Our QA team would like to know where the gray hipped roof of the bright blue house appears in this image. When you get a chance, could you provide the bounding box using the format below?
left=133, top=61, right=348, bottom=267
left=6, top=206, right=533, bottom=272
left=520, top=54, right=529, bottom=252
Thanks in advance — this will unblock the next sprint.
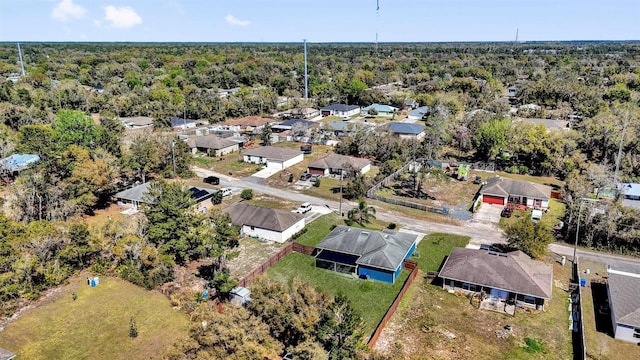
left=316, top=226, right=417, bottom=271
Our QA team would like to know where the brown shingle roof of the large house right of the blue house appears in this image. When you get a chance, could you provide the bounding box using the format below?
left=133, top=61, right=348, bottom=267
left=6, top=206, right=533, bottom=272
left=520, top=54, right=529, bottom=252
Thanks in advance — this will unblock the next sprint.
left=439, top=248, right=553, bottom=299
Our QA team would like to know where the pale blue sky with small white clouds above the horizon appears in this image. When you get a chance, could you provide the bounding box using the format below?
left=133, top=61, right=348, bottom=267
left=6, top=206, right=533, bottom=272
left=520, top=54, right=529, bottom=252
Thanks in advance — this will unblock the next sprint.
left=0, top=0, right=640, bottom=42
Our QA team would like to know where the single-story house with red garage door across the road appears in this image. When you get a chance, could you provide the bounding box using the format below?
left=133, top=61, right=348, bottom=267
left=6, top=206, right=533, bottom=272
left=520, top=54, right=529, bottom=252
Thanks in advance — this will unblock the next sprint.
left=480, top=176, right=551, bottom=210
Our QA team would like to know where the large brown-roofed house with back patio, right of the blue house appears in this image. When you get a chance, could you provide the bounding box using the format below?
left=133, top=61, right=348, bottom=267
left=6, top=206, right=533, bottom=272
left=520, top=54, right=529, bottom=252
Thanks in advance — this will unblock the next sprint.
left=438, top=248, right=553, bottom=309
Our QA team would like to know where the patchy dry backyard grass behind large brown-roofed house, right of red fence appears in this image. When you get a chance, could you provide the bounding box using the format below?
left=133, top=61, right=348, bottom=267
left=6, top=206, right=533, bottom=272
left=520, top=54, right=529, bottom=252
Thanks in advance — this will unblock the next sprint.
left=376, top=258, right=573, bottom=360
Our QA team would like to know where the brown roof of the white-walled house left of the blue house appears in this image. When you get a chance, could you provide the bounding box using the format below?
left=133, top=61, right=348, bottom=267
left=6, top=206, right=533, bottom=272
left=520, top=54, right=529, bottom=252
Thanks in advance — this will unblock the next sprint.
left=224, top=203, right=304, bottom=231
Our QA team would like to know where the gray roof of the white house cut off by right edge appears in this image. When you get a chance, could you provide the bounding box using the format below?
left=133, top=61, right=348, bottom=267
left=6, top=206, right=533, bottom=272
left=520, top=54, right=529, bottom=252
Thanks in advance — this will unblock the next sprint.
left=607, top=265, right=640, bottom=327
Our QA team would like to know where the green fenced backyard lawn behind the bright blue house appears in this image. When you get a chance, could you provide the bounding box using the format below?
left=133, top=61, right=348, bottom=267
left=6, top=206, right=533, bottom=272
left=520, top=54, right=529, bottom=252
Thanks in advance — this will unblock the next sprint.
left=266, top=253, right=409, bottom=341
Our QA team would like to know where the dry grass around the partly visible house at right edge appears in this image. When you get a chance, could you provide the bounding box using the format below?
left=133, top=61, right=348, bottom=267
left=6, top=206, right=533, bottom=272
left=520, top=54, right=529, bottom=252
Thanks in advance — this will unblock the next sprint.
left=580, top=260, right=640, bottom=360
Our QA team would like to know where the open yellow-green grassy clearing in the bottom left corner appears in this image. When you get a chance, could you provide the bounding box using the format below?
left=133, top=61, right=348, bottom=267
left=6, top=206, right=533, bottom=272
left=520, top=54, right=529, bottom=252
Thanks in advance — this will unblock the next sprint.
left=0, top=275, right=189, bottom=359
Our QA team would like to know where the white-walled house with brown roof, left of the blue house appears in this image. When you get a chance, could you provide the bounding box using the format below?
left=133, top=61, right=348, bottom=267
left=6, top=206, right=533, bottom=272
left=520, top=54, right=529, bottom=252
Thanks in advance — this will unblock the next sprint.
left=224, top=203, right=305, bottom=243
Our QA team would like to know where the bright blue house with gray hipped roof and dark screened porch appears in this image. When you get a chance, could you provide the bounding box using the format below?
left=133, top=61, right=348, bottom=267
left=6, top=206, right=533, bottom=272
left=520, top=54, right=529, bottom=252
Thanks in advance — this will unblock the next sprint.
left=316, top=225, right=418, bottom=283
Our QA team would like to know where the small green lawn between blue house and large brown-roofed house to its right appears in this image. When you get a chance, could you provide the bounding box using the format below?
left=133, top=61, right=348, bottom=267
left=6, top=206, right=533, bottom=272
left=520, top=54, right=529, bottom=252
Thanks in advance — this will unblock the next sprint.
left=411, top=233, right=469, bottom=271
